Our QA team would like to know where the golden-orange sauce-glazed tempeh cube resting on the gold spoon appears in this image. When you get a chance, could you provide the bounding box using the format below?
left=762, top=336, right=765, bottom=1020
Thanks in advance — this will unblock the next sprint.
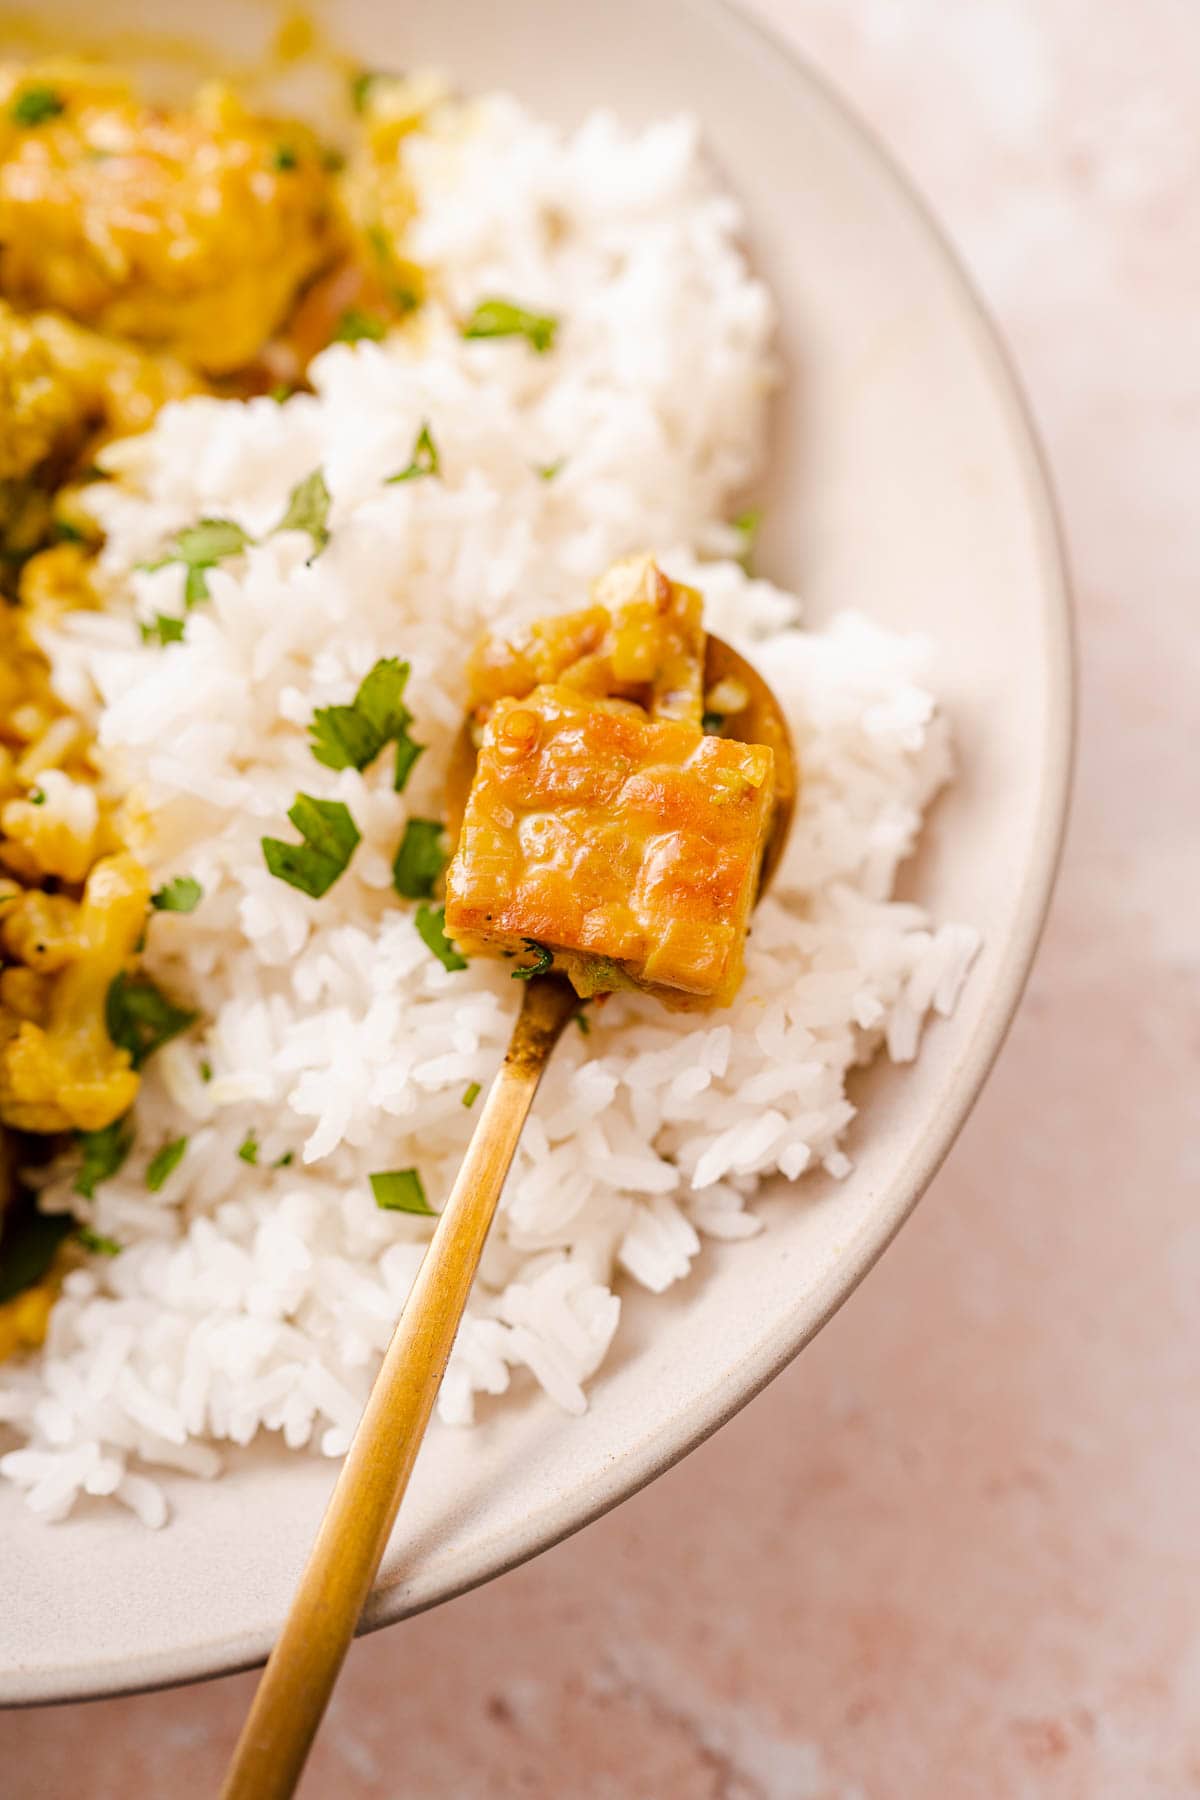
left=446, top=686, right=774, bottom=1006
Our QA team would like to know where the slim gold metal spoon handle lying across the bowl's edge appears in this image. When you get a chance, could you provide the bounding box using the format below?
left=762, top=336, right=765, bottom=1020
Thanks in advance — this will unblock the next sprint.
left=221, top=976, right=579, bottom=1800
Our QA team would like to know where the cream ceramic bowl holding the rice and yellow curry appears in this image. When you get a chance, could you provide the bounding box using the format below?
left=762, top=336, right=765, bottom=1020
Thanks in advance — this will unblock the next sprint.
left=0, top=0, right=1072, bottom=1703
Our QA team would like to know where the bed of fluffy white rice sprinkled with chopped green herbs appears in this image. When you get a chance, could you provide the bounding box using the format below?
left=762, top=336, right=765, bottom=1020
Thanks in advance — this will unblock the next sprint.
left=0, top=87, right=975, bottom=1525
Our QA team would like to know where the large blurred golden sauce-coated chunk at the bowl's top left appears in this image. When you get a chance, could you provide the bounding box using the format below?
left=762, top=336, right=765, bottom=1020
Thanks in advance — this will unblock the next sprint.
left=0, top=63, right=335, bottom=373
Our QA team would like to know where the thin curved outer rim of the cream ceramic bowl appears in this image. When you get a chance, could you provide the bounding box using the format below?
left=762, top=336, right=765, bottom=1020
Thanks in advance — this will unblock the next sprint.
left=0, top=0, right=1078, bottom=1710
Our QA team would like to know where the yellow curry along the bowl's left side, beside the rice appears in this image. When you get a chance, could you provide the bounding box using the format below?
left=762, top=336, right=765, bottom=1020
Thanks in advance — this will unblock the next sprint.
left=0, top=61, right=443, bottom=1357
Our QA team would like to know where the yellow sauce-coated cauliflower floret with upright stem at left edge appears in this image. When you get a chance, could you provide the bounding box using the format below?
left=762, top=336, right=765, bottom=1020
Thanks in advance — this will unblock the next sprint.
left=0, top=855, right=149, bottom=1132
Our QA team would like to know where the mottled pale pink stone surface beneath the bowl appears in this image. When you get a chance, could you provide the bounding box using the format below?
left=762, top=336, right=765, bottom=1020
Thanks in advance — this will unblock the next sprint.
left=0, top=0, right=1200, bottom=1800
